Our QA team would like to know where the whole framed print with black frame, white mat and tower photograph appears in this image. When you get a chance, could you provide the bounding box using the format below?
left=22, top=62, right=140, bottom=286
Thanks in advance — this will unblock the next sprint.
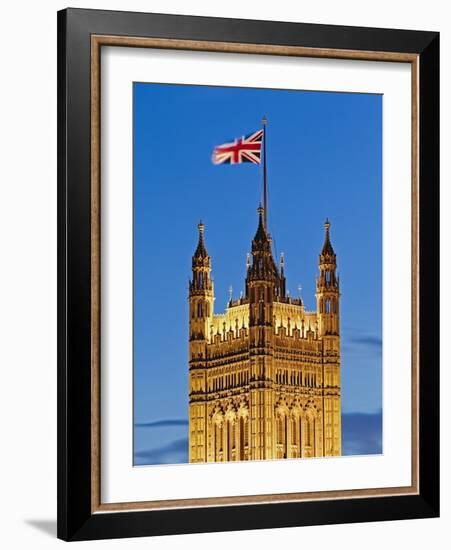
left=58, top=9, right=439, bottom=540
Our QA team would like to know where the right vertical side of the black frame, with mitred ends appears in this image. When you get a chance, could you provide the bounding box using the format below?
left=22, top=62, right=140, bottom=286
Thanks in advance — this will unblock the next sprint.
left=419, top=33, right=440, bottom=515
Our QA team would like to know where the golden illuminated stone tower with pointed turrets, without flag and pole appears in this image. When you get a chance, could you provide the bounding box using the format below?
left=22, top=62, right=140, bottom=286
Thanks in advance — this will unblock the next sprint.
left=189, top=207, right=341, bottom=463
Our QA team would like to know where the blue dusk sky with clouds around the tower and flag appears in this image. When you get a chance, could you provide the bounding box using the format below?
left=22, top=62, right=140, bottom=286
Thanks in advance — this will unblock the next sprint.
left=133, top=83, right=382, bottom=464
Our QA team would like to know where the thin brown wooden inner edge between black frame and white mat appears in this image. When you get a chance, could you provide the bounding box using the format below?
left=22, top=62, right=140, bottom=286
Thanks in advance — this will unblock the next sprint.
left=90, top=34, right=420, bottom=514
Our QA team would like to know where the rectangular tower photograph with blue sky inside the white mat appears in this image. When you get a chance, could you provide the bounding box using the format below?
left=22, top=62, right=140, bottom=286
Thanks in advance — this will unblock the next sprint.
left=130, top=82, right=384, bottom=467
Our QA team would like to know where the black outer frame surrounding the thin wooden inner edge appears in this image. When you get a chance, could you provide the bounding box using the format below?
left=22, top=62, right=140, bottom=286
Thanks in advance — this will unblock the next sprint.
left=57, top=9, right=439, bottom=540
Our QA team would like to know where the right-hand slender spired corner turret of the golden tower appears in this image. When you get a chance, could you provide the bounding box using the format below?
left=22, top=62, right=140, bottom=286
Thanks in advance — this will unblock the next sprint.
left=316, top=219, right=340, bottom=336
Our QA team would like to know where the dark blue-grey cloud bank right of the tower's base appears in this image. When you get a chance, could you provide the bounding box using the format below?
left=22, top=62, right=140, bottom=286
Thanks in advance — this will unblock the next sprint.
left=341, top=411, right=382, bottom=455
